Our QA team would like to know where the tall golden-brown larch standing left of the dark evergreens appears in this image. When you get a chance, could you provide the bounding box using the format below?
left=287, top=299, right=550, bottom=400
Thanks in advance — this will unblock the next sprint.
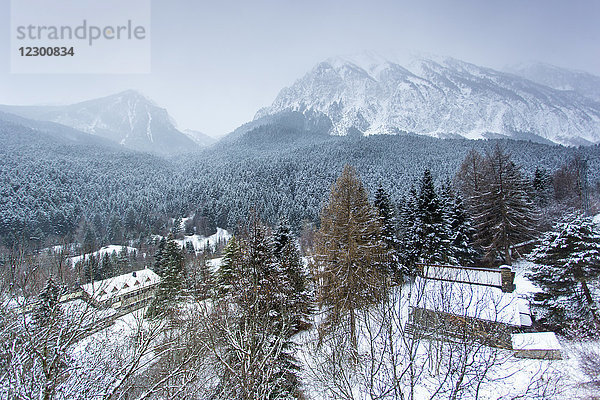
left=315, top=165, right=386, bottom=356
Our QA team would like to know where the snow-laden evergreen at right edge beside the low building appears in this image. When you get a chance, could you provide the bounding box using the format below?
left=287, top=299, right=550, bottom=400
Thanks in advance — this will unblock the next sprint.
left=529, top=214, right=600, bottom=336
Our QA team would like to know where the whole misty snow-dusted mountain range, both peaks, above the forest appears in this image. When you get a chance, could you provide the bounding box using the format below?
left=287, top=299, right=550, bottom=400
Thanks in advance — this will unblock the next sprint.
left=0, top=53, right=600, bottom=154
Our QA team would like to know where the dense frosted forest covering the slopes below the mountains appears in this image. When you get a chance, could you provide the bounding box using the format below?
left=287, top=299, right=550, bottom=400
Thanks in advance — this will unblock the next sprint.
left=0, top=117, right=600, bottom=245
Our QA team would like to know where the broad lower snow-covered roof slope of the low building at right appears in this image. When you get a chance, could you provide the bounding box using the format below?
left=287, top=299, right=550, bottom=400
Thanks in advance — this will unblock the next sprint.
left=412, top=277, right=531, bottom=326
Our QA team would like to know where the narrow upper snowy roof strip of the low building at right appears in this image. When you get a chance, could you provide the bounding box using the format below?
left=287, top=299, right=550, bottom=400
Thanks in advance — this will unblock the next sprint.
left=423, top=265, right=502, bottom=287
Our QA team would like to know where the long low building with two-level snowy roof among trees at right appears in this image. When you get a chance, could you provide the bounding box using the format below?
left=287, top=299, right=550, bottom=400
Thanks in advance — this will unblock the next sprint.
left=408, top=266, right=532, bottom=349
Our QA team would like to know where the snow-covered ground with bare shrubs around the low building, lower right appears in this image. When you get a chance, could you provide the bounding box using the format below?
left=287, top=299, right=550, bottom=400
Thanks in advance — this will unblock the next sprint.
left=295, top=261, right=600, bottom=400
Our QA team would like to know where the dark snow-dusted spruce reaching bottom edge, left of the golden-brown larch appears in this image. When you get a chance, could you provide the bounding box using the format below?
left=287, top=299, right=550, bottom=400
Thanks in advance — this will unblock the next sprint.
left=217, top=215, right=299, bottom=399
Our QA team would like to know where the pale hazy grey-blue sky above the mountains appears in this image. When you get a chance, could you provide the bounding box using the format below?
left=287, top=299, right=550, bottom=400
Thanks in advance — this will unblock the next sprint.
left=0, top=0, right=600, bottom=136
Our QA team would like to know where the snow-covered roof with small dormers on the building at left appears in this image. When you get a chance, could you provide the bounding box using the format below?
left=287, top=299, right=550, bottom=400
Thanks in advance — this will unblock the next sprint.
left=82, top=268, right=160, bottom=302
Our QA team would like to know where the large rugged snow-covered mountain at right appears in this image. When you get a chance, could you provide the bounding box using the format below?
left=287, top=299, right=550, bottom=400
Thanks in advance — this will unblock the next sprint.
left=255, top=54, right=600, bottom=145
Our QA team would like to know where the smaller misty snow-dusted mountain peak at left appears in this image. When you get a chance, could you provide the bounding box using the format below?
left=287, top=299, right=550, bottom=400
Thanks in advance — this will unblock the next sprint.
left=0, top=90, right=197, bottom=154
